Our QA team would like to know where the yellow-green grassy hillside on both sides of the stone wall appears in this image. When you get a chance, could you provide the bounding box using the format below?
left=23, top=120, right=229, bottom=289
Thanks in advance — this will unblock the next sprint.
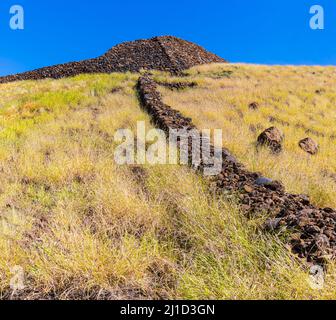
left=0, top=65, right=336, bottom=299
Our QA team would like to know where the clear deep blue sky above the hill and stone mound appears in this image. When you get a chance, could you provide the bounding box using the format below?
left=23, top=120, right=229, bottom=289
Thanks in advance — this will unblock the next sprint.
left=0, top=0, right=336, bottom=75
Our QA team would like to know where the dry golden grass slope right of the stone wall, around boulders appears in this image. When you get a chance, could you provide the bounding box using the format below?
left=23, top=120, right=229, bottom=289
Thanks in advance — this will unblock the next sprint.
left=157, top=64, right=336, bottom=207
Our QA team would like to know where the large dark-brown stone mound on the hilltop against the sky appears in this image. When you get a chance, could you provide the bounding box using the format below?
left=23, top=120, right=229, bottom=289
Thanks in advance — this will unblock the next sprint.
left=0, top=36, right=226, bottom=83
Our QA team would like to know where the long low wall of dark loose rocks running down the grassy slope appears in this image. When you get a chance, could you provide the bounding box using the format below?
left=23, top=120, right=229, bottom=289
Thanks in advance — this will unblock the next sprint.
left=138, top=77, right=336, bottom=264
